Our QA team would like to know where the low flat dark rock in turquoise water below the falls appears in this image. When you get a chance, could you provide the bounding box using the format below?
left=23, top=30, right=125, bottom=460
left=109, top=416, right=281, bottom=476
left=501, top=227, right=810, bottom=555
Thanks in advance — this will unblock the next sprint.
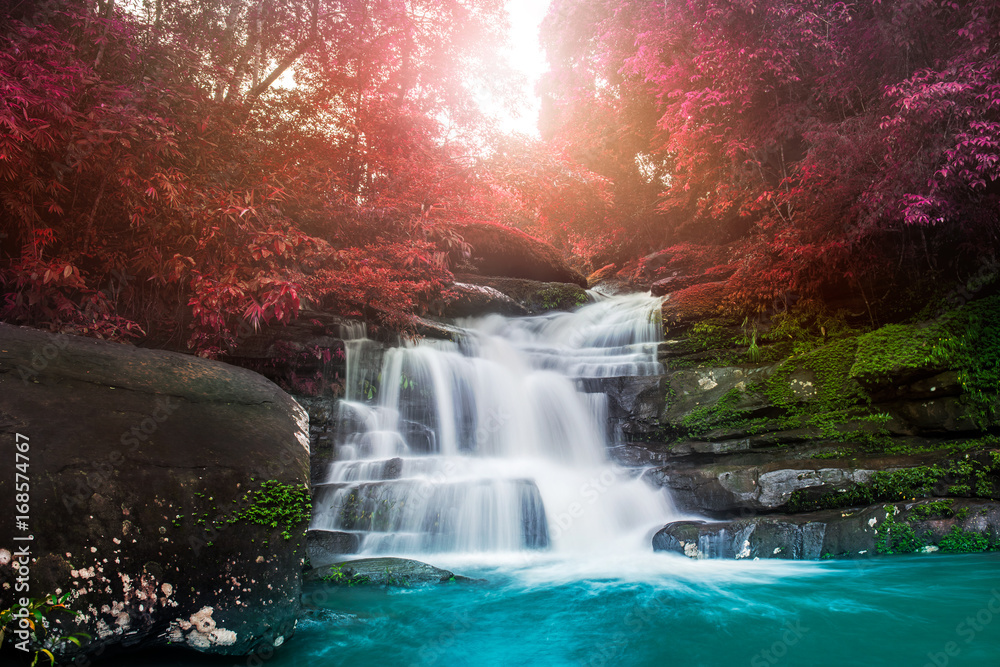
left=305, top=557, right=476, bottom=587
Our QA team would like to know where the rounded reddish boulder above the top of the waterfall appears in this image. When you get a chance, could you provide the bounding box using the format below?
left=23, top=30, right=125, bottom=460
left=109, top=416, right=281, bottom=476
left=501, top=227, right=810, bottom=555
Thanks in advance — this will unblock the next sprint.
left=454, top=222, right=587, bottom=287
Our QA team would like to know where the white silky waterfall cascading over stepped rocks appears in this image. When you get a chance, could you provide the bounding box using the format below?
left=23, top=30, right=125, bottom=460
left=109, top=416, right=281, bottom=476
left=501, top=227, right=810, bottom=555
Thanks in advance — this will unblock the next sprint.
left=312, top=295, right=671, bottom=554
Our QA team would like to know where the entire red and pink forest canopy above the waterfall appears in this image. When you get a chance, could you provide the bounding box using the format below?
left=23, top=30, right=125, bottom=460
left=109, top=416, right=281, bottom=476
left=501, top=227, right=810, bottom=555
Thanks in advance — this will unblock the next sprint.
left=0, top=0, right=1000, bottom=356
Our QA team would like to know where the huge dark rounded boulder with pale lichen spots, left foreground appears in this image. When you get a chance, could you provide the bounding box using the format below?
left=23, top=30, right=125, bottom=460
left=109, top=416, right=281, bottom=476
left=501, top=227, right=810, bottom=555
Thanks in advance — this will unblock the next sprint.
left=0, top=324, right=309, bottom=655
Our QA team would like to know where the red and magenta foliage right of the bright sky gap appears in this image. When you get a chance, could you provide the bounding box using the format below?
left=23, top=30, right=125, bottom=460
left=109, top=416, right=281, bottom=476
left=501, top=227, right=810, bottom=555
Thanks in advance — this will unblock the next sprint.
left=546, top=0, right=1000, bottom=310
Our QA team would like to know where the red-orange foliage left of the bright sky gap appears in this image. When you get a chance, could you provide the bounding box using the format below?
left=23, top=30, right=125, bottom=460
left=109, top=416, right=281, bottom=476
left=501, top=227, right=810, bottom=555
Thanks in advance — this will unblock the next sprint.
left=0, top=0, right=503, bottom=356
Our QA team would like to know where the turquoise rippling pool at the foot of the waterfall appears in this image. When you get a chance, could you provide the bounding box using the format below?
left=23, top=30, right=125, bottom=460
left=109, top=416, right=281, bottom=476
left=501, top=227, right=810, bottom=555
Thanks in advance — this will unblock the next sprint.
left=278, top=554, right=1000, bottom=667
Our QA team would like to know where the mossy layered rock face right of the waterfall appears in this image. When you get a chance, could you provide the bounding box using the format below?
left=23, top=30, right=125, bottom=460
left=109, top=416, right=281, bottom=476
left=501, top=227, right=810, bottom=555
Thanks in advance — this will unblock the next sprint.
left=584, top=290, right=1000, bottom=558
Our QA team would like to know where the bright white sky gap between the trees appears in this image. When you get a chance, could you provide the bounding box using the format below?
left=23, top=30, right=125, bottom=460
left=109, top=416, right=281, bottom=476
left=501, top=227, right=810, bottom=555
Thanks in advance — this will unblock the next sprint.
left=500, top=0, right=551, bottom=137
